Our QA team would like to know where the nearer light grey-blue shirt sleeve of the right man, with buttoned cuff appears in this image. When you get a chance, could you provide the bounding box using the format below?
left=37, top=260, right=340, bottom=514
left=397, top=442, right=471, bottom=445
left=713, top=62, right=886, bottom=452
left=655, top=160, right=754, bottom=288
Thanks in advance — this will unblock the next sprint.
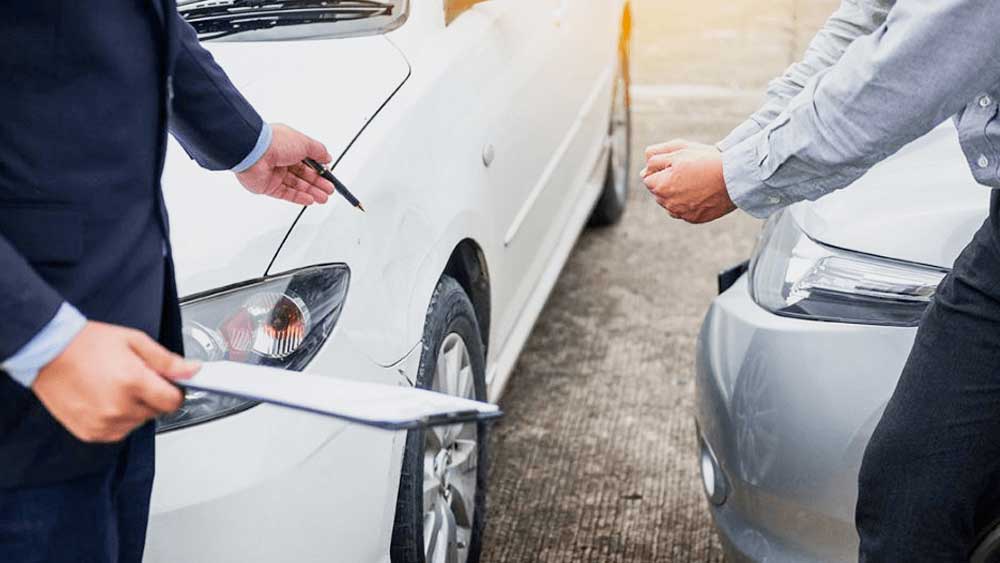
left=723, top=0, right=1000, bottom=217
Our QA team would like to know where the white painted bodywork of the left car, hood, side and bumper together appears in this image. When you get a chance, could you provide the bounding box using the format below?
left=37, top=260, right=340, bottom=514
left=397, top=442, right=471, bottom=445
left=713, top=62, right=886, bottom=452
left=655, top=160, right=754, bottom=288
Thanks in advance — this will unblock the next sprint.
left=146, top=0, right=624, bottom=563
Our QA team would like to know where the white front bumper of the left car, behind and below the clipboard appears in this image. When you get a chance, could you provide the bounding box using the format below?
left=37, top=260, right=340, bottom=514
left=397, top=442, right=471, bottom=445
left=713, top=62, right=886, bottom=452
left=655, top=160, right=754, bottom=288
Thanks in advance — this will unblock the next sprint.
left=145, top=334, right=419, bottom=563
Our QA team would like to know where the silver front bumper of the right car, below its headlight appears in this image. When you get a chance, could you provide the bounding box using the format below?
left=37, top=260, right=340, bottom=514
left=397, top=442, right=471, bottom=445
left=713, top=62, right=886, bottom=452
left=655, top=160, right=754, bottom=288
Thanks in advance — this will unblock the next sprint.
left=695, top=276, right=916, bottom=562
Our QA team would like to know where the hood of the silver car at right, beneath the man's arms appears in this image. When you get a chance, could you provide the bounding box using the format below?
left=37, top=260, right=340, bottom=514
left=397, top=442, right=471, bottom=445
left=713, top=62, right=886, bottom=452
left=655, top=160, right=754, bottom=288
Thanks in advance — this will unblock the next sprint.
left=792, top=124, right=991, bottom=268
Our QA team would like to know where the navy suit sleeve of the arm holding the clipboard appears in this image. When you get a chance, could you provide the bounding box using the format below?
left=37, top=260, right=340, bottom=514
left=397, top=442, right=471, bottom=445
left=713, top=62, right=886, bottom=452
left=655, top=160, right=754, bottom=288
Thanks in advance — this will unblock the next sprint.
left=0, top=235, right=64, bottom=362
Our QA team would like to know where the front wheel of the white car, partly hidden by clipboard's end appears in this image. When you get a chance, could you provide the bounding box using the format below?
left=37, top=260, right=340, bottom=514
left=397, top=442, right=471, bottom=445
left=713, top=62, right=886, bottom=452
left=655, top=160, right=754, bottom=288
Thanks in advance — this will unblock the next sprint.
left=390, top=276, right=488, bottom=563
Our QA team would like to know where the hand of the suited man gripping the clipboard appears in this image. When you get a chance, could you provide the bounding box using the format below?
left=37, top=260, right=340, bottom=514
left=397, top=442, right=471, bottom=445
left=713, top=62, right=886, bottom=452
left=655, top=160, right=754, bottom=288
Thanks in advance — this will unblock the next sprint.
left=31, top=322, right=199, bottom=442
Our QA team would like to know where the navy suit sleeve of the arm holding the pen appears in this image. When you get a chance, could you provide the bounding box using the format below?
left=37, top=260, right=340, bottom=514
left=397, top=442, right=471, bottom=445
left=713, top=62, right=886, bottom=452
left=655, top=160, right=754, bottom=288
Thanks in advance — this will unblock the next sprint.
left=170, top=14, right=265, bottom=170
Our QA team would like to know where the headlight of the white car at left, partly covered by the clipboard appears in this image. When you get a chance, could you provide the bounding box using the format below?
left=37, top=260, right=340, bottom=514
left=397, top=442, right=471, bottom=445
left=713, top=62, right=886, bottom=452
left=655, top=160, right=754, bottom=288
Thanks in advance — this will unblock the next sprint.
left=158, top=265, right=350, bottom=432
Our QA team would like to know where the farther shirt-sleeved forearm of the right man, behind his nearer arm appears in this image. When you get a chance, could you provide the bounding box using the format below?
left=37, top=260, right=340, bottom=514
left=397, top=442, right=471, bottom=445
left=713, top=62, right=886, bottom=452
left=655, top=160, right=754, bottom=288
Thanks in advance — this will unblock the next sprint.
left=718, top=0, right=891, bottom=150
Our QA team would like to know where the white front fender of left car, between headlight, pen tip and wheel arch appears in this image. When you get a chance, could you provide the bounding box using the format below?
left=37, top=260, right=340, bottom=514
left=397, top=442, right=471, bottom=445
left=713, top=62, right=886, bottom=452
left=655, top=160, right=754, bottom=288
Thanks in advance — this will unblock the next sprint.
left=268, top=93, right=492, bottom=366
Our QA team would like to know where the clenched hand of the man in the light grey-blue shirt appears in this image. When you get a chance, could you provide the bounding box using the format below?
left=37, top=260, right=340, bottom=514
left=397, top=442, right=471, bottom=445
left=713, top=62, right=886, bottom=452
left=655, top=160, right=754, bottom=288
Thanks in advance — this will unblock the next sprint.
left=642, top=139, right=736, bottom=223
